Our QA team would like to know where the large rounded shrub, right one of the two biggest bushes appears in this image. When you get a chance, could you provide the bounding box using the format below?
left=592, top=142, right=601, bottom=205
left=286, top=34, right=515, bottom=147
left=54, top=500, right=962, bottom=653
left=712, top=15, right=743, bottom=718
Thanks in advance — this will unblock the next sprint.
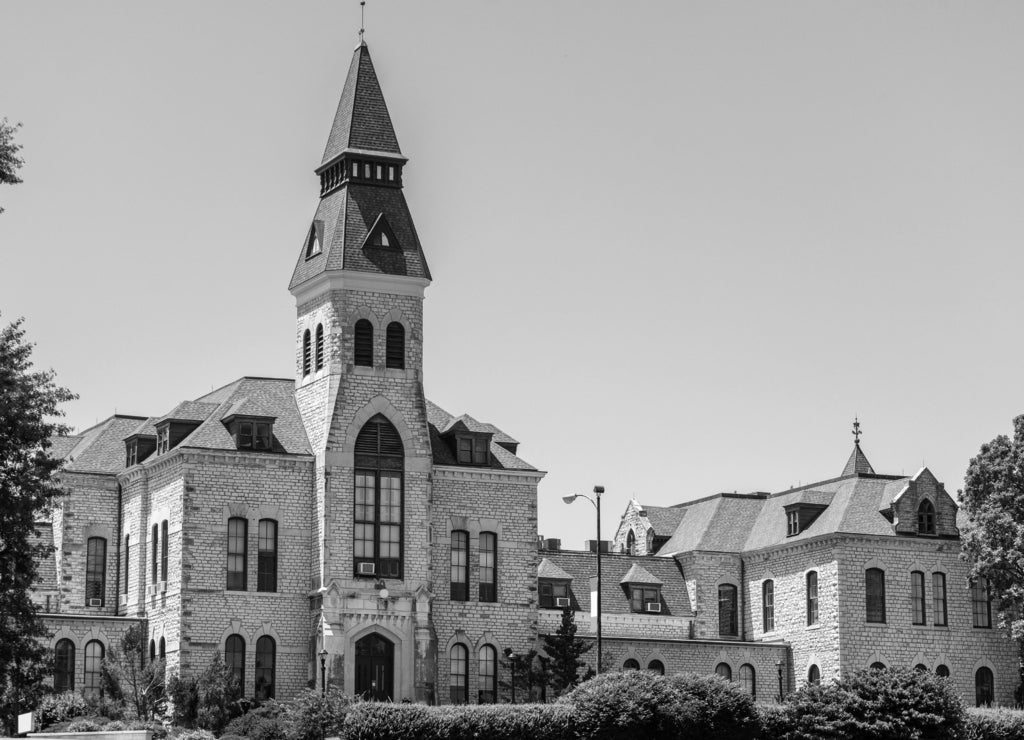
left=780, top=668, right=966, bottom=740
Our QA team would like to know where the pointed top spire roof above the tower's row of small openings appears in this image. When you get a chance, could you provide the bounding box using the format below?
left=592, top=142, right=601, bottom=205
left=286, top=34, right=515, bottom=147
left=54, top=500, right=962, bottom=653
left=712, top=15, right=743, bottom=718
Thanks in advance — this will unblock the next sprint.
left=321, top=42, right=401, bottom=165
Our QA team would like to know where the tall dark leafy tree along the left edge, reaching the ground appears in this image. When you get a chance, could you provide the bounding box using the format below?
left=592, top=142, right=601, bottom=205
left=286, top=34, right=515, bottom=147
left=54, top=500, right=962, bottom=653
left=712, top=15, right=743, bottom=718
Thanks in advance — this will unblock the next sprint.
left=0, top=317, right=75, bottom=730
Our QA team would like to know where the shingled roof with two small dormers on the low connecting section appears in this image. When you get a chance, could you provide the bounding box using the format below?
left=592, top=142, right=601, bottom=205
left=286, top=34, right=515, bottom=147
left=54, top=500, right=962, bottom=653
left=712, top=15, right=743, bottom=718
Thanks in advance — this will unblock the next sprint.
left=542, top=551, right=693, bottom=616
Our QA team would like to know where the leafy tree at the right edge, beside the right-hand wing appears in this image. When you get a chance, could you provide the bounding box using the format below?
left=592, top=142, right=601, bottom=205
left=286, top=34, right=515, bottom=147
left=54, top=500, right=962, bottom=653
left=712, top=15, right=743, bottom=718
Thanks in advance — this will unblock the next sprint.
left=959, top=416, right=1024, bottom=691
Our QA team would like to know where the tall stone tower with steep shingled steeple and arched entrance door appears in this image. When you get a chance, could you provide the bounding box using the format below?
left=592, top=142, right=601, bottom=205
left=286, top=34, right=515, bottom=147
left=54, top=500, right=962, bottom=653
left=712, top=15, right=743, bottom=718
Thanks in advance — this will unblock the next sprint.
left=289, top=42, right=436, bottom=701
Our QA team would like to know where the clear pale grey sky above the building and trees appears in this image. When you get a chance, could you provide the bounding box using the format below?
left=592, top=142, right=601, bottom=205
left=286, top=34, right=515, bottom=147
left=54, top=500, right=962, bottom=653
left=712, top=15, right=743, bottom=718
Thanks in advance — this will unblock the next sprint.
left=0, top=0, right=1024, bottom=547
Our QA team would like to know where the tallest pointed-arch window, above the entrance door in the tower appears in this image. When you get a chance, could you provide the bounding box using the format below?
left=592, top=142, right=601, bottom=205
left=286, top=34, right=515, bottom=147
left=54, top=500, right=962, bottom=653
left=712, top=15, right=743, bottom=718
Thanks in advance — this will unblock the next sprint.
left=353, top=417, right=404, bottom=578
